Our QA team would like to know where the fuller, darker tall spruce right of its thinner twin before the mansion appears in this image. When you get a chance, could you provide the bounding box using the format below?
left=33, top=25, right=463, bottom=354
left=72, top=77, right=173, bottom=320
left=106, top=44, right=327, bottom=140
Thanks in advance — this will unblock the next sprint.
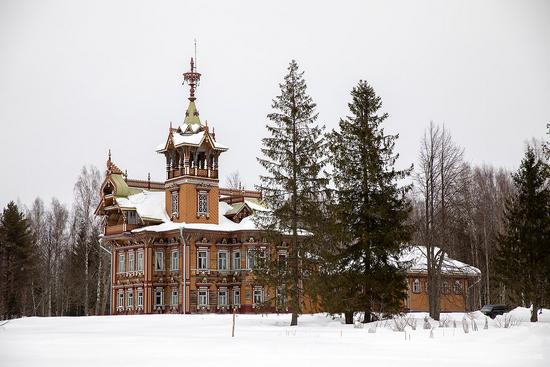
left=321, top=81, right=412, bottom=322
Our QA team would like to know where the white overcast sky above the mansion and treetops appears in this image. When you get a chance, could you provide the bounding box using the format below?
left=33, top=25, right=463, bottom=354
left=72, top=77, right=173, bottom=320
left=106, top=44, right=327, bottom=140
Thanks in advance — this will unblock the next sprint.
left=0, top=0, right=550, bottom=211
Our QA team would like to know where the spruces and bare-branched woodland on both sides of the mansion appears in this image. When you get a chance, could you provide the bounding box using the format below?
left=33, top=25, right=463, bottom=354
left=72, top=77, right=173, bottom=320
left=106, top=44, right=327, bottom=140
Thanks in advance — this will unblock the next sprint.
left=0, top=61, right=550, bottom=325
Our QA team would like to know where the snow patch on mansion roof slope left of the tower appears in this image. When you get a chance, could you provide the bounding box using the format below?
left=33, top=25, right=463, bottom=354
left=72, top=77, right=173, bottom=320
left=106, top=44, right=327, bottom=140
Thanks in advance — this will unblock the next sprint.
left=116, top=190, right=170, bottom=222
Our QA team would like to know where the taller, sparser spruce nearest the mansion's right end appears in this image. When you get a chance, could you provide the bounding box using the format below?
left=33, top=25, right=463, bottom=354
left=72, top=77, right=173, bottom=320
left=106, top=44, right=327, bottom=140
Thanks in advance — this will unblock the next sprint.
left=257, top=60, right=327, bottom=326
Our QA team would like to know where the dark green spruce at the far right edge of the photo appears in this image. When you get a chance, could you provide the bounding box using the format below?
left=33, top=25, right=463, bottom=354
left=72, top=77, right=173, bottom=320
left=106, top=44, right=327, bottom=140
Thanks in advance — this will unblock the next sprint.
left=496, top=147, right=550, bottom=322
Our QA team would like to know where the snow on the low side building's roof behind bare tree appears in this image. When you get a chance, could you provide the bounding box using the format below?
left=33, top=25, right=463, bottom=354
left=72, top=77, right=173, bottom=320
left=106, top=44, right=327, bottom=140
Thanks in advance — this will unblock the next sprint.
left=399, top=246, right=481, bottom=275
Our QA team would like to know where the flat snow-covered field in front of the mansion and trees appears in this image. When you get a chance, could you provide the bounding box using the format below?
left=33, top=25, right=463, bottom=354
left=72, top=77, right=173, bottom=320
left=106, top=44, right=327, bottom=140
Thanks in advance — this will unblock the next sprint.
left=0, top=309, right=550, bottom=367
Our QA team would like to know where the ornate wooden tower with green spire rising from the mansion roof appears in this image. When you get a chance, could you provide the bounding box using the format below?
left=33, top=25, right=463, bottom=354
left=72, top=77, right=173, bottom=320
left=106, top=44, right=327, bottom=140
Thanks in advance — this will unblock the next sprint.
left=157, top=58, right=227, bottom=224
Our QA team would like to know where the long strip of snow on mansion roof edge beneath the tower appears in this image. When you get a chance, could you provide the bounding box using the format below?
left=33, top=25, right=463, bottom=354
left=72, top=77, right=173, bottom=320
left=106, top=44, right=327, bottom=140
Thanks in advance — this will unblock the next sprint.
left=132, top=201, right=259, bottom=233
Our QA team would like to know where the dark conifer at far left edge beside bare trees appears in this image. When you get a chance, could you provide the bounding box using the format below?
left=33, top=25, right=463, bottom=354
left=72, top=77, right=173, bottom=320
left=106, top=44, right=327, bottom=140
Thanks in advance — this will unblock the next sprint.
left=0, top=201, right=35, bottom=317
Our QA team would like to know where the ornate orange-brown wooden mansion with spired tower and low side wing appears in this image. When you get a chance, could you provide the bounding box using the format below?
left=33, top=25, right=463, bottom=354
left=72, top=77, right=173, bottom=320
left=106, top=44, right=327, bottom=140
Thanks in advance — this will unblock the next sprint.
left=96, top=59, right=480, bottom=314
